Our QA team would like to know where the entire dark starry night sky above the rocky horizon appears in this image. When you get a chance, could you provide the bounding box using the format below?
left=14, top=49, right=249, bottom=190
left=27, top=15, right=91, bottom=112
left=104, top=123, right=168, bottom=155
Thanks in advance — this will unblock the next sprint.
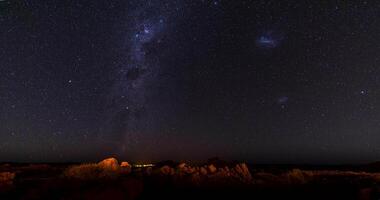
left=0, top=0, right=380, bottom=164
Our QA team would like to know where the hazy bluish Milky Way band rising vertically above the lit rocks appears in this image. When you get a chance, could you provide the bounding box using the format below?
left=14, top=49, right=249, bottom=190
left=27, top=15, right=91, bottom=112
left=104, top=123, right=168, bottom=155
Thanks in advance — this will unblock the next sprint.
left=112, top=1, right=181, bottom=156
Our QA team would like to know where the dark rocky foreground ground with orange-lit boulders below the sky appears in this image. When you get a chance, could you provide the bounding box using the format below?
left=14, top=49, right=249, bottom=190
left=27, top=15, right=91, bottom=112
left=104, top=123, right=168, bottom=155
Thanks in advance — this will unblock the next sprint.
left=0, top=158, right=380, bottom=200
